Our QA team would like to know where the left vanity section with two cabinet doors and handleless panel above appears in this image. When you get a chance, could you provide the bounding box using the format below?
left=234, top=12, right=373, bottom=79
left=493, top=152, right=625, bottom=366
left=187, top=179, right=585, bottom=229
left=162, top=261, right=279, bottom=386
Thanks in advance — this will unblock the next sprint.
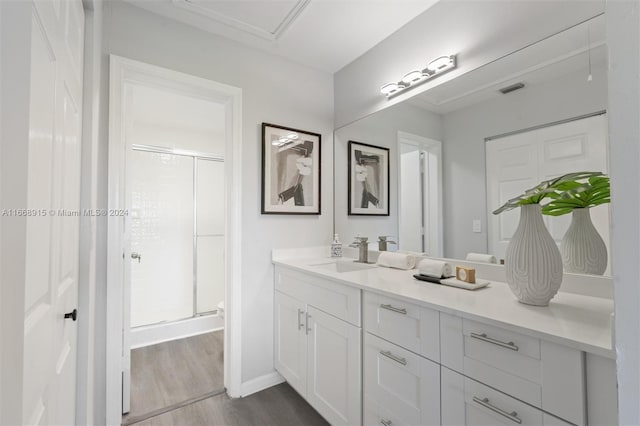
left=274, top=267, right=362, bottom=425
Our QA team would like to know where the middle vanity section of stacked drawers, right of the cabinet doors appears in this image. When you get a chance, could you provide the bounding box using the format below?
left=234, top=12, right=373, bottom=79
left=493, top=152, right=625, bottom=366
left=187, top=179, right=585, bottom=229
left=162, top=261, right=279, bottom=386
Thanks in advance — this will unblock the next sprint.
left=363, top=292, right=440, bottom=426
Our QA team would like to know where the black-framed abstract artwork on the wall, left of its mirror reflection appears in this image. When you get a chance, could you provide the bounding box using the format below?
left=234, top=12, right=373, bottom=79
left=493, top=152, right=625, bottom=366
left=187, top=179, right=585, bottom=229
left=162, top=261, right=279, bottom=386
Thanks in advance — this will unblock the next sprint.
left=261, top=123, right=322, bottom=214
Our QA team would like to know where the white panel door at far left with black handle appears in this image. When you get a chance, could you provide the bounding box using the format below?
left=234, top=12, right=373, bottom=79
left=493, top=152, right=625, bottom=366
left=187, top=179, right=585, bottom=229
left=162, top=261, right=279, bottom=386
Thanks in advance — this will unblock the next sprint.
left=22, top=0, right=86, bottom=425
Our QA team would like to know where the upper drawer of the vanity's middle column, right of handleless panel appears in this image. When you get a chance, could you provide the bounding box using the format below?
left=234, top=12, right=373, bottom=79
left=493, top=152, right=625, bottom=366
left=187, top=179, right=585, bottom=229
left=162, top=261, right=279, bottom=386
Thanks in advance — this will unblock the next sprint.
left=364, top=292, right=440, bottom=362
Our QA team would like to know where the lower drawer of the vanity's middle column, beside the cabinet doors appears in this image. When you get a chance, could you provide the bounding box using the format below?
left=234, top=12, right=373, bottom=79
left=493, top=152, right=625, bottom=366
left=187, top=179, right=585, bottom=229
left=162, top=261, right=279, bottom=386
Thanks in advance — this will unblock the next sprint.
left=363, top=333, right=440, bottom=425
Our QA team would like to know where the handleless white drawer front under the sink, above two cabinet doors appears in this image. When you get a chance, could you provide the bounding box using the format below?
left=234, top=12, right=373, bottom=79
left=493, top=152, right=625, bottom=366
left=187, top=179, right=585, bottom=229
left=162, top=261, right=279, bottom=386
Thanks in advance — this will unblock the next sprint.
left=275, top=267, right=361, bottom=327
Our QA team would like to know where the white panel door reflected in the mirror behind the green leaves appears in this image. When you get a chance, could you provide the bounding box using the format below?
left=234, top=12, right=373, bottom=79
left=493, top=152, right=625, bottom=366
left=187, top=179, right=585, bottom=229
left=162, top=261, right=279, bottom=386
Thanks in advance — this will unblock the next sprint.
left=486, top=114, right=610, bottom=264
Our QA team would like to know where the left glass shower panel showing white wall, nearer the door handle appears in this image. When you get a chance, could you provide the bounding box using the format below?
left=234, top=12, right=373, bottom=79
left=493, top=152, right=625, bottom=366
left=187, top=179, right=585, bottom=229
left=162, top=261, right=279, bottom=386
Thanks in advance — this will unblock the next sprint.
left=130, top=150, right=194, bottom=327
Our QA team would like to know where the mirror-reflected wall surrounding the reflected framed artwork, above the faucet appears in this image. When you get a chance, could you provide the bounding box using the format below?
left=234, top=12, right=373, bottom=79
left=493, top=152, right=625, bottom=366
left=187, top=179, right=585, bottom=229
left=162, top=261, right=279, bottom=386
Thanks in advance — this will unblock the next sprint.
left=334, top=103, right=442, bottom=248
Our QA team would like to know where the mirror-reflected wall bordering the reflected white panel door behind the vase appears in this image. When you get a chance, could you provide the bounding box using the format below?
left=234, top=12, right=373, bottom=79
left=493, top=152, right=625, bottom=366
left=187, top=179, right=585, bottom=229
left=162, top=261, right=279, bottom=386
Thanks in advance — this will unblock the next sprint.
left=443, top=65, right=607, bottom=259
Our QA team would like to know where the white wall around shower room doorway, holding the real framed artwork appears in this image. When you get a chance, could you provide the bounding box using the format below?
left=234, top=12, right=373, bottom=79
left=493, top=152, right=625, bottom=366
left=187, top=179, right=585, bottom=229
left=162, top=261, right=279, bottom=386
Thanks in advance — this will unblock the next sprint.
left=98, top=2, right=333, bottom=402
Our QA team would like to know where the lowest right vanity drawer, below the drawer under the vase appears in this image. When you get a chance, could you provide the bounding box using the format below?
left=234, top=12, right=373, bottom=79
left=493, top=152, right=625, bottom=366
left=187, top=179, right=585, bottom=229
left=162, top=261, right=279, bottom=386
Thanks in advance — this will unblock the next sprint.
left=442, top=368, right=570, bottom=426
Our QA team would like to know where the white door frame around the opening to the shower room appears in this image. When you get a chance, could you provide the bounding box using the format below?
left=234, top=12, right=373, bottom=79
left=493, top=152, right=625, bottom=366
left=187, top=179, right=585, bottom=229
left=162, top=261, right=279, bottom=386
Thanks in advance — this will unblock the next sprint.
left=106, top=55, right=242, bottom=425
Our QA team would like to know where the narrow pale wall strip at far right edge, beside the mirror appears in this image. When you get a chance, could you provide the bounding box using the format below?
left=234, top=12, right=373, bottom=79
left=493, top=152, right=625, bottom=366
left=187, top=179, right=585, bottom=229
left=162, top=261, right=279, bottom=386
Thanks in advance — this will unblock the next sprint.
left=606, top=0, right=640, bottom=425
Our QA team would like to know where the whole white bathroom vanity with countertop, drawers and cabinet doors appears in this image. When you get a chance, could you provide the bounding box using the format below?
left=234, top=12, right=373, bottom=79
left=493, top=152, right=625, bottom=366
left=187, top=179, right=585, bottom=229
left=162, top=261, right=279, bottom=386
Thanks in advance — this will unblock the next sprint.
left=273, top=249, right=617, bottom=426
